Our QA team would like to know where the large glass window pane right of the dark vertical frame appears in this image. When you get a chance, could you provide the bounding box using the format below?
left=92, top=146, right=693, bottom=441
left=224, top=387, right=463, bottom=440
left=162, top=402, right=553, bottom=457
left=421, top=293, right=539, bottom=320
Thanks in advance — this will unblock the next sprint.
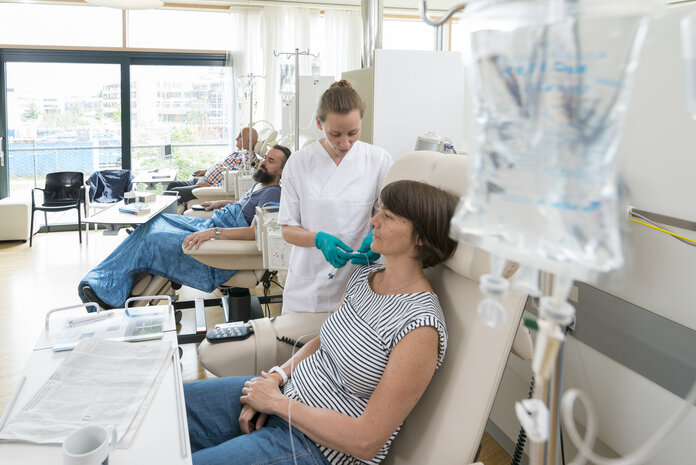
left=131, top=65, right=236, bottom=179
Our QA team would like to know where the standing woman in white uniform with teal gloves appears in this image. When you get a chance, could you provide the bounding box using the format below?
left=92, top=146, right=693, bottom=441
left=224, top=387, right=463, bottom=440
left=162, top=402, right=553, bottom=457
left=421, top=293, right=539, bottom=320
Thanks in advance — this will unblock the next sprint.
left=278, top=80, right=393, bottom=314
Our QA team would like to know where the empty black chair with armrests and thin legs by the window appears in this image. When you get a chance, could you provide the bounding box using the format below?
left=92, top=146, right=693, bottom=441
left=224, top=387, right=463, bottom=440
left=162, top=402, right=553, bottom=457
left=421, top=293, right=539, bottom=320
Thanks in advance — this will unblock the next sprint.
left=29, top=171, right=87, bottom=247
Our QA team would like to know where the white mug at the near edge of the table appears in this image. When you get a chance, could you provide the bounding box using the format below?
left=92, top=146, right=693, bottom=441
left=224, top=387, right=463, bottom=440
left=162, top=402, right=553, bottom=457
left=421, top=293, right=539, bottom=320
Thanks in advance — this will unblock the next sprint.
left=63, top=425, right=118, bottom=465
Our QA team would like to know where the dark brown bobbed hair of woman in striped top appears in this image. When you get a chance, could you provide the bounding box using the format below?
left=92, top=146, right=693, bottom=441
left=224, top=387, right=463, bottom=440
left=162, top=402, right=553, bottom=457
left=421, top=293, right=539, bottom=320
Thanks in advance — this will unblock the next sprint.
left=380, top=180, right=459, bottom=268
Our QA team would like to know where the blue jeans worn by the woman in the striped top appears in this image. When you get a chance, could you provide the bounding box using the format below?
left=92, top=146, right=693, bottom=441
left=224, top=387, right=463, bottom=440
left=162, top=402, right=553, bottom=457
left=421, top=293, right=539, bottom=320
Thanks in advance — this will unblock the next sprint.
left=184, top=376, right=328, bottom=465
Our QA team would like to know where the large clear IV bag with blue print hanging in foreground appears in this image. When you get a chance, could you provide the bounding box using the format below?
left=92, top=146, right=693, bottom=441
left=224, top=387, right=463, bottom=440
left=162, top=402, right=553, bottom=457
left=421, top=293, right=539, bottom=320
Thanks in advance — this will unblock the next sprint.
left=451, top=0, right=654, bottom=280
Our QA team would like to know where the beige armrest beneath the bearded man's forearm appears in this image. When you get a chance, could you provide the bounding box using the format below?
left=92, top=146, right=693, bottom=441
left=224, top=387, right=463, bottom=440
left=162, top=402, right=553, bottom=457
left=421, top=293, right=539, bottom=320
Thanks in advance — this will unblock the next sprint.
left=182, top=240, right=264, bottom=270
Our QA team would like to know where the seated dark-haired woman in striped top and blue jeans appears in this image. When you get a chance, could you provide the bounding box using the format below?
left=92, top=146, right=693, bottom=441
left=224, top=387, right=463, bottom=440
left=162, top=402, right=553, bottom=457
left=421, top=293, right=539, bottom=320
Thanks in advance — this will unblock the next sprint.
left=184, top=181, right=457, bottom=465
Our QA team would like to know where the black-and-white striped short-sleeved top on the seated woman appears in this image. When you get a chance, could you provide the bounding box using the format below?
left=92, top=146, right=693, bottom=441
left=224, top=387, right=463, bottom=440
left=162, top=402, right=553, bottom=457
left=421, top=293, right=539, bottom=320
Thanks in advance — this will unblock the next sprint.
left=284, top=264, right=447, bottom=465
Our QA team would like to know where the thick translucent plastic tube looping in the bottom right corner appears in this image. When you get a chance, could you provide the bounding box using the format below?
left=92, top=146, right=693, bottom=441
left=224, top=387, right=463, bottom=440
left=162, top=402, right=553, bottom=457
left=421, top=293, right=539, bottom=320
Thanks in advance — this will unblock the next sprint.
left=561, top=381, right=696, bottom=465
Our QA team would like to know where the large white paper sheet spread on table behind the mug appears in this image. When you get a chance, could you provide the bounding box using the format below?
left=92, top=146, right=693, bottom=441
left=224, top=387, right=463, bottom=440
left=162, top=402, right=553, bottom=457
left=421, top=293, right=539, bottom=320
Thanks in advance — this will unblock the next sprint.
left=0, top=338, right=174, bottom=447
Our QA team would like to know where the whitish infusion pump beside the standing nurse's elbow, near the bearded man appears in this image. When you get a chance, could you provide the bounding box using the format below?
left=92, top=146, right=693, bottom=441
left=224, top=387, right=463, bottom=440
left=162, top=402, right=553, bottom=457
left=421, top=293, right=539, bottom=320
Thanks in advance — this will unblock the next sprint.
left=254, top=206, right=292, bottom=271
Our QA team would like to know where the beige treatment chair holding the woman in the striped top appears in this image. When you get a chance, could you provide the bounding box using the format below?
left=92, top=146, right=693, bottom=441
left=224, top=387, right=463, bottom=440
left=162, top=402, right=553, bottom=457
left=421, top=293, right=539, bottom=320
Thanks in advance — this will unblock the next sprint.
left=188, top=151, right=532, bottom=465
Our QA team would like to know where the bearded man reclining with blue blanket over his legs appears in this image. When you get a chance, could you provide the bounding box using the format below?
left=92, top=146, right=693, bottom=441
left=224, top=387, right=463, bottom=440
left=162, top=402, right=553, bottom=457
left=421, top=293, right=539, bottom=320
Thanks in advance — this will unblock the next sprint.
left=78, top=145, right=290, bottom=308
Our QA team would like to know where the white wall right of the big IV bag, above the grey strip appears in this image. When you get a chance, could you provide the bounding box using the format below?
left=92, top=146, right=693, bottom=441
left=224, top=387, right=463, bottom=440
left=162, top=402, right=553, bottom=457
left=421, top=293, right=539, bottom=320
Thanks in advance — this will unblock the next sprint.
left=599, top=2, right=696, bottom=330
